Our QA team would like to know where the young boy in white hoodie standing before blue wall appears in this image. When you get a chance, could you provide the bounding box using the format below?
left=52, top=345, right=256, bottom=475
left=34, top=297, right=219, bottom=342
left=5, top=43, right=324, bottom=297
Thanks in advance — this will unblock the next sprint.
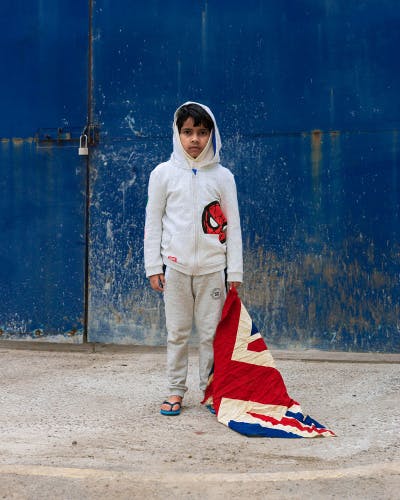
left=144, top=102, right=243, bottom=415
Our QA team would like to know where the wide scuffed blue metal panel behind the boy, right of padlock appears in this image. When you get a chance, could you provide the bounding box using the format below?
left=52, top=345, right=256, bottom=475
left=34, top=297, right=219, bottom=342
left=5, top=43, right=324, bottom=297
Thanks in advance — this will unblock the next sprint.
left=89, top=0, right=400, bottom=351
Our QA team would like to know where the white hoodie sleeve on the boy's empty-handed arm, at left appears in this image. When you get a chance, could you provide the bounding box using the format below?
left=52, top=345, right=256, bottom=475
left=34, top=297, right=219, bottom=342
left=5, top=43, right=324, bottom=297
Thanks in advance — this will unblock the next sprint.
left=144, top=168, right=166, bottom=277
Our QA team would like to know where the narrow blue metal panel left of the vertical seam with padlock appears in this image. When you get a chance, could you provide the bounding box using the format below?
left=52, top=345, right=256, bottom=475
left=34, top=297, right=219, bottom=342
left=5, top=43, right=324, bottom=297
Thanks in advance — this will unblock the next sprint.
left=0, top=0, right=88, bottom=342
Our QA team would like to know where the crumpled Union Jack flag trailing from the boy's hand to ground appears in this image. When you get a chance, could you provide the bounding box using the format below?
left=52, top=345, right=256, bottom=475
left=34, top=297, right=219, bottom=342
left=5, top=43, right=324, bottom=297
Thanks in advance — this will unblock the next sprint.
left=202, top=288, right=335, bottom=438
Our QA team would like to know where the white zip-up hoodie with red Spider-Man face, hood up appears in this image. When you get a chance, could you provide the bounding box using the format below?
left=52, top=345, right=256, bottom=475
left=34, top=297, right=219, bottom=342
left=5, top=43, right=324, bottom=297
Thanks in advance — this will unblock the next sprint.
left=144, top=102, right=243, bottom=282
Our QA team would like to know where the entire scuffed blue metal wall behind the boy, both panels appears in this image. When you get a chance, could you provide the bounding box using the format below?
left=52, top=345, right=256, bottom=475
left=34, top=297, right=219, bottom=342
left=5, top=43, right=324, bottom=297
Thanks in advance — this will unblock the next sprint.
left=0, top=0, right=400, bottom=352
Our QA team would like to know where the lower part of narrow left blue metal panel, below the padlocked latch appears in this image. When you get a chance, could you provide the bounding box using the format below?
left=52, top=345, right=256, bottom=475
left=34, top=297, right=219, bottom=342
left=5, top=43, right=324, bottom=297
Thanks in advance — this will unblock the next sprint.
left=0, top=141, right=85, bottom=341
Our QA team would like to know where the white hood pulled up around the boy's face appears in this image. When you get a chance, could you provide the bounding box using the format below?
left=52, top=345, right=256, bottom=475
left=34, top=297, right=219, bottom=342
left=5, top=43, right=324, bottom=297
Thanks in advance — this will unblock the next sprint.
left=171, top=101, right=221, bottom=169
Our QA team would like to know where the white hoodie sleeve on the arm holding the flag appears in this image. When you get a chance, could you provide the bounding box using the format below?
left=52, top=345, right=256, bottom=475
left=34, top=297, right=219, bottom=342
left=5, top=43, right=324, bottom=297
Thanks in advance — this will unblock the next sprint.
left=221, top=170, right=243, bottom=282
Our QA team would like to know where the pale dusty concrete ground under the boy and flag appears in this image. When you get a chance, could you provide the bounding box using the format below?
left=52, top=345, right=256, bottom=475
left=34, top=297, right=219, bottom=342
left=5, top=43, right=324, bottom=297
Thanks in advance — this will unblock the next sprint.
left=0, top=341, right=400, bottom=500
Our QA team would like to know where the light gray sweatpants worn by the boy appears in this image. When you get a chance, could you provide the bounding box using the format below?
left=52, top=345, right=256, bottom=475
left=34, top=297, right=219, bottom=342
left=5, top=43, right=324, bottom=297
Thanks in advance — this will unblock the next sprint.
left=164, top=268, right=226, bottom=397
